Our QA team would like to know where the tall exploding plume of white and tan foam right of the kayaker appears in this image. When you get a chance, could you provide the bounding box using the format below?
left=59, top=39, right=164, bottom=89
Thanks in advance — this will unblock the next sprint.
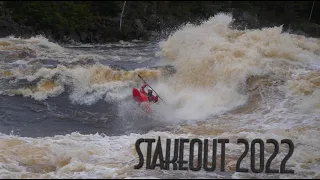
left=154, top=14, right=319, bottom=123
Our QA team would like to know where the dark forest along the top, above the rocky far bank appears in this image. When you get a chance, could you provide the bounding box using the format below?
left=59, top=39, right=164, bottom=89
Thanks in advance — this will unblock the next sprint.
left=1, top=1, right=320, bottom=42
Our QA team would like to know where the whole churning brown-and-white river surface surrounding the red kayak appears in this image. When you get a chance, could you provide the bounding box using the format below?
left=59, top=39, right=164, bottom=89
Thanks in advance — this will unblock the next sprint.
left=0, top=14, right=320, bottom=178
